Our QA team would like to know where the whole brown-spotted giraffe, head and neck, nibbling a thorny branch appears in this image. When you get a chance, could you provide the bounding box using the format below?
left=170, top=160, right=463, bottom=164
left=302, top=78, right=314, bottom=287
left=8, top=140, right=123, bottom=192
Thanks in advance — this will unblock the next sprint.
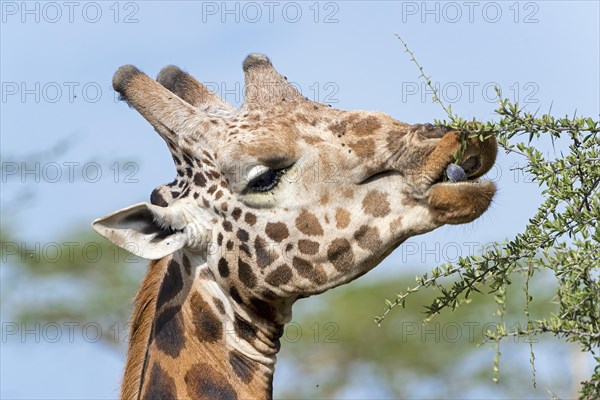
left=92, top=54, right=496, bottom=399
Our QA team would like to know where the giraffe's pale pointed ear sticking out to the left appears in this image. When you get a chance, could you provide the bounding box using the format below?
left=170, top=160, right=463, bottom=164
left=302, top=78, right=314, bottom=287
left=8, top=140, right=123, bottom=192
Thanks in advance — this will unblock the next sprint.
left=92, top=203, right=188, bottom=260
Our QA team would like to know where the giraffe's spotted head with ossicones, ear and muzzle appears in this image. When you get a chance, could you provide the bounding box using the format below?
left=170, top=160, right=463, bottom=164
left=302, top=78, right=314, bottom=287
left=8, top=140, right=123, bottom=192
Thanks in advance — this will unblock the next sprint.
left=93, top=55, right=496, bottom=324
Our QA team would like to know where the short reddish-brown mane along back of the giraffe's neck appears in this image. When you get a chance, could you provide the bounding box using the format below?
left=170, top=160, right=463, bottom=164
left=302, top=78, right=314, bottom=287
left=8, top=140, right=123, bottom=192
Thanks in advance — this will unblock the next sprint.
left=120, top=256, right=171, bottom=400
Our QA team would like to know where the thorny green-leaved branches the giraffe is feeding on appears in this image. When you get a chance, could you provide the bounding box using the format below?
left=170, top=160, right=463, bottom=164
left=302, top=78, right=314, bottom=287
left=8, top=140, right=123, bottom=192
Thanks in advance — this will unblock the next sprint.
left=375, top=39, right=600, bottom=399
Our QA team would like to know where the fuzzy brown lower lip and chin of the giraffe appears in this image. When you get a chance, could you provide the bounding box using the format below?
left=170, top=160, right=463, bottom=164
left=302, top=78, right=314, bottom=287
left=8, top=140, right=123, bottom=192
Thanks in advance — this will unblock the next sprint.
left=428, top=180, right=496, bottom=225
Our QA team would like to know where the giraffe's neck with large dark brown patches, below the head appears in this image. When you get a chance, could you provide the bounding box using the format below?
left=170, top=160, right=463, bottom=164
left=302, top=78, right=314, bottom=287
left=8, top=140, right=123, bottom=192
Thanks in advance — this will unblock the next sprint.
left=122, top=252, right=282, bottom=400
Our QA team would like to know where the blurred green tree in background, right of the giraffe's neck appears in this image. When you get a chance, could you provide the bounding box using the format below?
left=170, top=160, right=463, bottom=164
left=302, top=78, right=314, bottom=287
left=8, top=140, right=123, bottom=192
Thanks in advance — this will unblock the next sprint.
left=280, top=276, right=572, bottom=399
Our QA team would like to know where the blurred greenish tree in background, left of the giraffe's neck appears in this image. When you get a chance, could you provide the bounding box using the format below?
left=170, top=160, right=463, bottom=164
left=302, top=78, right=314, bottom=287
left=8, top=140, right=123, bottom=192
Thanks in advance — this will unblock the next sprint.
left=0, top=227, right=147, bottom=351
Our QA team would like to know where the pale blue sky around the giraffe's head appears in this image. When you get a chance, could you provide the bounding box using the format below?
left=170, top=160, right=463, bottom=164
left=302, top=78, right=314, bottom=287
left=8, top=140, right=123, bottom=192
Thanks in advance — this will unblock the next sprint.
left=0, top=1, right=600, bottom=397
